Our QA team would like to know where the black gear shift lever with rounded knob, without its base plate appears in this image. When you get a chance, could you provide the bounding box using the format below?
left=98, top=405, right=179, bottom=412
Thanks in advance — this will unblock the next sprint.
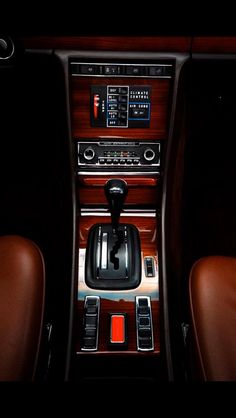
left=105, top=179, right=128, bottom=234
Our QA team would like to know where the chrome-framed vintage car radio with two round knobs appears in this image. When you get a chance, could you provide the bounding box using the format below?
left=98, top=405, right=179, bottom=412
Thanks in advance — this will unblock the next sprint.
left=77, top=141, right=161, bottom=171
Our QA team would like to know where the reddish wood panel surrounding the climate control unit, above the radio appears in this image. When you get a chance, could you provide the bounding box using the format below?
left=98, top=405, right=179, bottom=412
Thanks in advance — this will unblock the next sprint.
left=70, top=76, right=171, bottom=140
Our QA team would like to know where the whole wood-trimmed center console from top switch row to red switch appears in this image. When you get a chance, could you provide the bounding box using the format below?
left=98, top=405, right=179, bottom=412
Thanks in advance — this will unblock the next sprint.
left=65, top=54, right=175, bottom=378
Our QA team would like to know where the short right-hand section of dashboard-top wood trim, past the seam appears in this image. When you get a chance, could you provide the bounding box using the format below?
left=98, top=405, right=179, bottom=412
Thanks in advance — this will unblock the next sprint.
left=192, top=36, right=236, bottom=54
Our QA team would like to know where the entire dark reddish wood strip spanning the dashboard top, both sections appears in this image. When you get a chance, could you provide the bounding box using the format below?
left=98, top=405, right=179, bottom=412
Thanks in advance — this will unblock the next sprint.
left=20, top=36, right=236, bottom=54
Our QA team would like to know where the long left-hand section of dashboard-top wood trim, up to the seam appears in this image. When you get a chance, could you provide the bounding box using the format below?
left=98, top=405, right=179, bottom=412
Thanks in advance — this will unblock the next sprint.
left=21, top=36, right=191, bottom=52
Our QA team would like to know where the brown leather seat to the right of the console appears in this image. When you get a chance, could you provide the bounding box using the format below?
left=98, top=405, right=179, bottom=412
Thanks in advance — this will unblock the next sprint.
left=189, top=256, right=236, bottom=381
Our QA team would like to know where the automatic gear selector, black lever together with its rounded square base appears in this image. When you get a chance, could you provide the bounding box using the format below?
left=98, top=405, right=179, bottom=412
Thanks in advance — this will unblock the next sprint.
left=85, top=179, right=141, bottom=290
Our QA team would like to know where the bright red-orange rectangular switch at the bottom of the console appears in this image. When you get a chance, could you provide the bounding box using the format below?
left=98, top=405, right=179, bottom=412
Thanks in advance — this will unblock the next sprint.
left=110, top=314, right=127, bottom=347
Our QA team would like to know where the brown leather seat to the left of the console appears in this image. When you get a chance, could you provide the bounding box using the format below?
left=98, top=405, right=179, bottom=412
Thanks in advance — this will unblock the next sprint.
left=0, top=236, right=45, bottom=381
